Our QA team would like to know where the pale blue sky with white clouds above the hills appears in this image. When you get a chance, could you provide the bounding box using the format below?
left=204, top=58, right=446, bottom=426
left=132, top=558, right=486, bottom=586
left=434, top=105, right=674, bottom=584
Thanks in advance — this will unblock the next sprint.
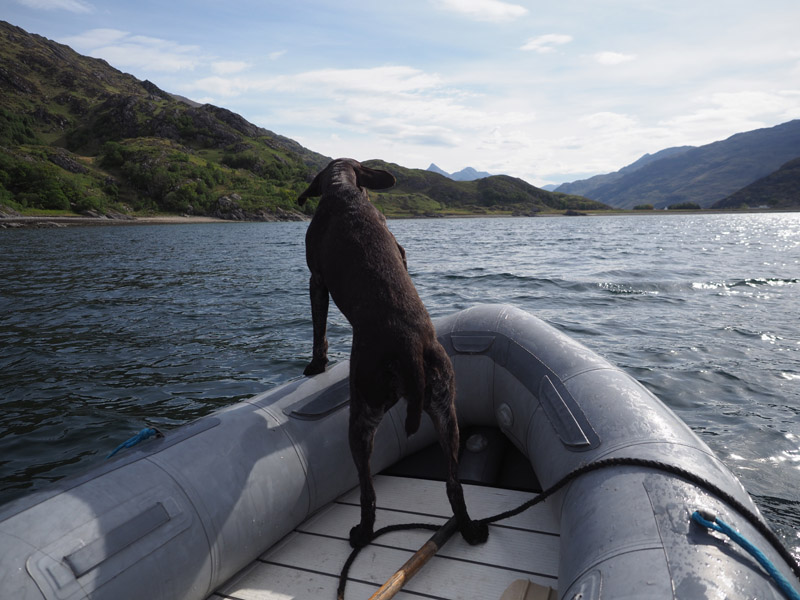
left=0, top=0, right=800, bottom=186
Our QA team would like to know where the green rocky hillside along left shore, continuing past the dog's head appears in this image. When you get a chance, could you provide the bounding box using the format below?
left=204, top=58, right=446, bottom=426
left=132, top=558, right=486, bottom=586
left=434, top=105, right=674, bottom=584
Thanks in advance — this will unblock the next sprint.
left=0, top=21, right=600, bottom=220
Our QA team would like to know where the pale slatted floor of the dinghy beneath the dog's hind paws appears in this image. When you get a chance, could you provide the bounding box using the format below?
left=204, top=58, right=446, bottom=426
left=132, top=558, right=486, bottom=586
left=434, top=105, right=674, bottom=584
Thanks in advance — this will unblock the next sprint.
left=209, top=475, right=559, bottom=600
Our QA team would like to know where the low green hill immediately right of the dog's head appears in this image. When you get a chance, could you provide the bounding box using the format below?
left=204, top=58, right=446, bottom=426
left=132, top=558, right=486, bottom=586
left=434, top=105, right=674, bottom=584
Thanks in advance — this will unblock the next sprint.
left=364, top=160, right=608, bottom=216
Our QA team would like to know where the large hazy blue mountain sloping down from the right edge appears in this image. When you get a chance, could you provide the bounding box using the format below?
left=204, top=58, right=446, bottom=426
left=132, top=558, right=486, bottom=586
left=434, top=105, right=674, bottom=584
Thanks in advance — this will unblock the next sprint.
left=558, top=120, right=800, bottom=208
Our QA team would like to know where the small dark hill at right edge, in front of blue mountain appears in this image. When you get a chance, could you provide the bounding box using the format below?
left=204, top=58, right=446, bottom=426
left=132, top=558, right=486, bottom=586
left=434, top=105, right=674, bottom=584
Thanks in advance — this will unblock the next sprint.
left=711, top=158, right=800, bottom=210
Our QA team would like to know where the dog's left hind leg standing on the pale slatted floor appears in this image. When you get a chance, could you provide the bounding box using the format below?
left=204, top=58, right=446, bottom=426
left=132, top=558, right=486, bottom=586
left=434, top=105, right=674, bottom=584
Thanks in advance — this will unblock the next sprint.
left=349, top=386, right=383, bottom=548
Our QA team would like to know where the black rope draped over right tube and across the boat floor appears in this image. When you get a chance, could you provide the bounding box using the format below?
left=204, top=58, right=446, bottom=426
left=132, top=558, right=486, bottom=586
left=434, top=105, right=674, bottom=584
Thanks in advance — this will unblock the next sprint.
left=337, top=457, right=800, bottom=600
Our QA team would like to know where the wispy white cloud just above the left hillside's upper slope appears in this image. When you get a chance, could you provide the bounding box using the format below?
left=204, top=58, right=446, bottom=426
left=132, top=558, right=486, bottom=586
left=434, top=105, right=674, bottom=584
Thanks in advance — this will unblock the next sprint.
left=62, top=29, right=208, bottom=73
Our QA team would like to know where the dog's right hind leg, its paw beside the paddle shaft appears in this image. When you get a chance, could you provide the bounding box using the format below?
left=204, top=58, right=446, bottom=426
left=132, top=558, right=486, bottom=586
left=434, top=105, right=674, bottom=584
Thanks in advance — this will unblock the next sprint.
left=425, top=351, right=489, bottom=545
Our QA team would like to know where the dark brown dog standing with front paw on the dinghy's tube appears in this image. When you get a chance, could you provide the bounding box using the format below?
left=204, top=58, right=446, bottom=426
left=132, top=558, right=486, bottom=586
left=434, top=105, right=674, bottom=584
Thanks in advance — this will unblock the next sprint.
left=297, top=158, right=489, bottom=548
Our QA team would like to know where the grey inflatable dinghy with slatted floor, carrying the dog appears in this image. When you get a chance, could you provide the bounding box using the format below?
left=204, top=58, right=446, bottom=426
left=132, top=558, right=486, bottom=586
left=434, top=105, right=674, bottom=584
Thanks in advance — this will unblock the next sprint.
left=0, top=305, right=798, bottom=600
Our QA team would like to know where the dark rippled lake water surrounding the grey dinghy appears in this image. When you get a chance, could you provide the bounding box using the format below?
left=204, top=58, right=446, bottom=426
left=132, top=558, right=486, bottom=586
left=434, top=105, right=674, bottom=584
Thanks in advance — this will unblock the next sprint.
left=0, top=213, right=800, bottom=556
